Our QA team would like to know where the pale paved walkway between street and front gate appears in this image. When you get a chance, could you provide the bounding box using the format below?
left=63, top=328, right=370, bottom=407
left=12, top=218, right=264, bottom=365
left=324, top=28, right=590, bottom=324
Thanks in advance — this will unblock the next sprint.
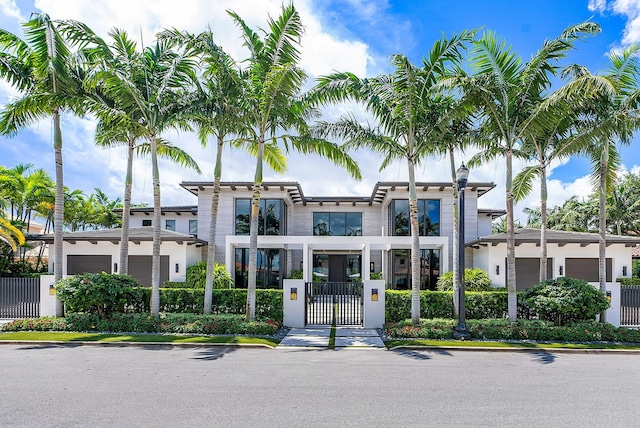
left=277, top=326, right=386, bottom=349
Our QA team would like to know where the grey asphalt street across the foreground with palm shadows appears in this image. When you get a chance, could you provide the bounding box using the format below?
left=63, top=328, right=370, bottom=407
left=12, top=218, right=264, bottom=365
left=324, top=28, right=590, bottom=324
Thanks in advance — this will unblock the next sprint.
left=0, top=345, right=640, bottom=427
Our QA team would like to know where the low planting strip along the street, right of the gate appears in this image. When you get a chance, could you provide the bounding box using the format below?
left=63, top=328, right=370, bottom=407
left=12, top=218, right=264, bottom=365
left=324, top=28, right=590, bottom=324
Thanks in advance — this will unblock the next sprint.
left=384, top=319, right=640, bottom=343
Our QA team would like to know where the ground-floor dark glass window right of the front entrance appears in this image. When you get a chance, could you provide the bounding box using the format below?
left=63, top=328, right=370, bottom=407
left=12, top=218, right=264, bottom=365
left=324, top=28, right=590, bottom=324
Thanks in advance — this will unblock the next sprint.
left=390, top=250, right=440, bottom=290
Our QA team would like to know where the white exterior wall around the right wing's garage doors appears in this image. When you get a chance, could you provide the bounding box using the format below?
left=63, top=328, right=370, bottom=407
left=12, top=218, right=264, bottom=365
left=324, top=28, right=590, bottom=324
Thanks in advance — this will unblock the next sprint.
left=473, top=243, right=631, bottom=287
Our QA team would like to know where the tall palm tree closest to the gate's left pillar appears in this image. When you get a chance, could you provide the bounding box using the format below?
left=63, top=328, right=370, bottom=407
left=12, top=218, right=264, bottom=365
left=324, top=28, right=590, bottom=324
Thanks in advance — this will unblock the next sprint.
left=229, top=4, right=360, bottom=320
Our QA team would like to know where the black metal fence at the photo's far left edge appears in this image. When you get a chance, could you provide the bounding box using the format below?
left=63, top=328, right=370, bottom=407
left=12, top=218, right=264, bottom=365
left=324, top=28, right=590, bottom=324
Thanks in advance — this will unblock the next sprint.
left=0, top=278, right=40, bottom=318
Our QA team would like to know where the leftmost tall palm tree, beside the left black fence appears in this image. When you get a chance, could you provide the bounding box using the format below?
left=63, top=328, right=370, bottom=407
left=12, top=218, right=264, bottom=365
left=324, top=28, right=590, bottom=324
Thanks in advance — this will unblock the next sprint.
left=0, top=14, right=82, bottom=315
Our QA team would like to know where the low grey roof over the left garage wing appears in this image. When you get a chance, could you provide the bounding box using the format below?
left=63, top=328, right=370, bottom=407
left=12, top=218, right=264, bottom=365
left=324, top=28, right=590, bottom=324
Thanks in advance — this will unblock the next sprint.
left=28, top=226, right=207, bottom=245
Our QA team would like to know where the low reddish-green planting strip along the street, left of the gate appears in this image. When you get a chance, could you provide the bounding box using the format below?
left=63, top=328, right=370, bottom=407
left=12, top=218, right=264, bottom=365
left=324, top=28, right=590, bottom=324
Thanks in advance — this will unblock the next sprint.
left=3, top=313, right=282, bottom=336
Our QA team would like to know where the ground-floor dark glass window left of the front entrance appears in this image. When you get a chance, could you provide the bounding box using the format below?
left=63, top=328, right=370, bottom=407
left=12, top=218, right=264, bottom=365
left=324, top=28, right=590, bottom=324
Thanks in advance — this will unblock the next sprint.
left=235, top=248, right=282, bottom=288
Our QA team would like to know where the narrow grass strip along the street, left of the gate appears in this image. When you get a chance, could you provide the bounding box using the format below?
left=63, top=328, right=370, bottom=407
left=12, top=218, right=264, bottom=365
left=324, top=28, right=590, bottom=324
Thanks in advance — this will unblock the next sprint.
left=0, top=331, right=280, bottom=347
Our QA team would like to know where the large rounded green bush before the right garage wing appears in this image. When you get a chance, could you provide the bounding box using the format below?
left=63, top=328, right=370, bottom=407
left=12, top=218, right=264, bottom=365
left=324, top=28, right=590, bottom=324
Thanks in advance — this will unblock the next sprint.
left=522, top=277, right=609, bottom=325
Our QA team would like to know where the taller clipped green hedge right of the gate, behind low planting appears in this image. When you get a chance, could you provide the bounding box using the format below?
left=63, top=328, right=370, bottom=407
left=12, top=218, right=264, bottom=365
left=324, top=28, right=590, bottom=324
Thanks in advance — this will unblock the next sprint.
left=385, top=289, right=535, bottom=322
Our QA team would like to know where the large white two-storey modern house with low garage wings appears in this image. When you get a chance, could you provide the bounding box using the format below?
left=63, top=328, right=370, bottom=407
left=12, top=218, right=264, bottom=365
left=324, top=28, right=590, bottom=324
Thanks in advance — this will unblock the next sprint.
left=33, top=182, right=640, bottom=289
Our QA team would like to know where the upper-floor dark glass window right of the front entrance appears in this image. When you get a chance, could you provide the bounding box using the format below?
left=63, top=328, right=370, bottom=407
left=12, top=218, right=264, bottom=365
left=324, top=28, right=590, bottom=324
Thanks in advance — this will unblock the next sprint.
left=390, top=199, right=440, bottom=236
